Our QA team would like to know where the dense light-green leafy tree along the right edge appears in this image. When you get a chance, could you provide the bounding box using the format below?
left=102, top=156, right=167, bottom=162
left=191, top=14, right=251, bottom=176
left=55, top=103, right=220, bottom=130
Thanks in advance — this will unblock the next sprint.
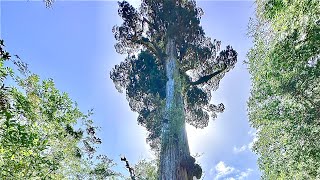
left=248, top=0, right=320, bottom=179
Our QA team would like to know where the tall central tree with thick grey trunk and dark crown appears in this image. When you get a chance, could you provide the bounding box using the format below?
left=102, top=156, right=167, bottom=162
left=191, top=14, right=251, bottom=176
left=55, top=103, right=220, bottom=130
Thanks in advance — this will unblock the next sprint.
left=110, top=0, right=237, bottom=180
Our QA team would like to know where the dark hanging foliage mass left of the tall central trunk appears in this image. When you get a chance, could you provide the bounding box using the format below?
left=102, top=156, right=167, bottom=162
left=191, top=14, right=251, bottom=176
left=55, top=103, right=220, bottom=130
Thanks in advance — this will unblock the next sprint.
left=110, top=51, right=167, bottom=148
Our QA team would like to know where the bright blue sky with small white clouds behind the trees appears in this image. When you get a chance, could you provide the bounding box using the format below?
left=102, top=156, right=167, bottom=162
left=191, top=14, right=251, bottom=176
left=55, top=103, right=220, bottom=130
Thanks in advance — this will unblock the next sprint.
left=0, top=0, right=260, bottom=180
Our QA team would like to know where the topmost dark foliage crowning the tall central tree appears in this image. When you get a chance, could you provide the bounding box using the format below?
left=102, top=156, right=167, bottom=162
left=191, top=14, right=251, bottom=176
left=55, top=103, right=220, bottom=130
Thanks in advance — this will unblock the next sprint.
left=113, top=0, right=204, bottom=62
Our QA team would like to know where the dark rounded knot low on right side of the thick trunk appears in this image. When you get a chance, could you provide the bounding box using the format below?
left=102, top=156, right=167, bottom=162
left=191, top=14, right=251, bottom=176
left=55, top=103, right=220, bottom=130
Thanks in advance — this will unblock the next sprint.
left=180, top=156, right=202, bottom=179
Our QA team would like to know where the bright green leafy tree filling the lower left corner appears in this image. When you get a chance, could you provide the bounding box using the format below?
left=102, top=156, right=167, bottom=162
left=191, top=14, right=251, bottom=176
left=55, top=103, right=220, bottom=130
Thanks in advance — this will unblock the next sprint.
left=0, top=40, right=117, bottom=179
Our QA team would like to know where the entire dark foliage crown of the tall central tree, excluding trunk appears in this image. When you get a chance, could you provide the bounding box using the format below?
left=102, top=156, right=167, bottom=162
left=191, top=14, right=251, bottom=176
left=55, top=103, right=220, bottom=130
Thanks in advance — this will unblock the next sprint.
left=110, top=0, right=237, bottom=147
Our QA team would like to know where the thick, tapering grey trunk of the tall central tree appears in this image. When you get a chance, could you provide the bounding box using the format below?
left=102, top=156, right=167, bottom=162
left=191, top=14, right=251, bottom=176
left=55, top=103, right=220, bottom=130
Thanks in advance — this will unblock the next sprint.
left=159, top=40, right=192, bottom=180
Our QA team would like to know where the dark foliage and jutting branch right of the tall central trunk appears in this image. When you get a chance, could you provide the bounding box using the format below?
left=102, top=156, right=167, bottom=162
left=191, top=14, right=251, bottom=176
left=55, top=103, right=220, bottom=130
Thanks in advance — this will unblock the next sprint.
left=185, top=46, right=237, bottom=128
